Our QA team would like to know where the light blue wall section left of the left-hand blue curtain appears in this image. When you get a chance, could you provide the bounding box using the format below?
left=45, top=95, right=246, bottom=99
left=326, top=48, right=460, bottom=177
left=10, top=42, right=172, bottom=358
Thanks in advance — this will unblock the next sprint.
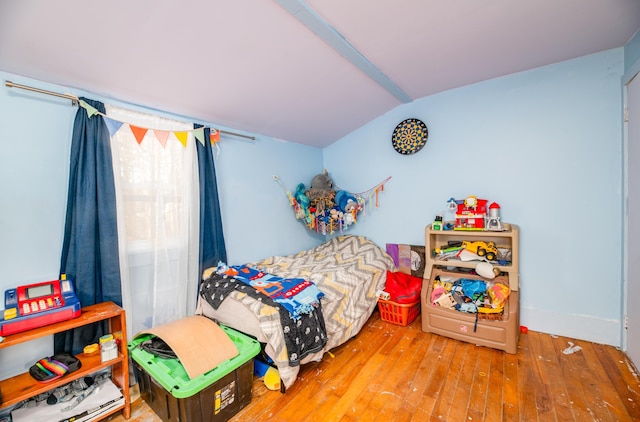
left=0, top=73, right=75, bottom=379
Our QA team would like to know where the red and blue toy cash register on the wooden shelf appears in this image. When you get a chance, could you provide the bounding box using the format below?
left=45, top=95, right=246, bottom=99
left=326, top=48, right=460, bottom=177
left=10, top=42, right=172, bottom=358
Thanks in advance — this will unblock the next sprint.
left=0, top=274, right=82, bottom=336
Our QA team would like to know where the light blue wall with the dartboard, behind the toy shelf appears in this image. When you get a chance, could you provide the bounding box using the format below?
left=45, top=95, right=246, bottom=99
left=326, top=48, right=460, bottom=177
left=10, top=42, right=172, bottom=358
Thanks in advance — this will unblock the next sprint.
left=324, top=48, right=624, bottom=345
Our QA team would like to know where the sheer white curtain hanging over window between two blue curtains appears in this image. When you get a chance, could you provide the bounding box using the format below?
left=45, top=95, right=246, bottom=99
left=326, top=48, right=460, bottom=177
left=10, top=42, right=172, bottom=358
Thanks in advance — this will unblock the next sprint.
left=106, top=105, right=199, bottom=338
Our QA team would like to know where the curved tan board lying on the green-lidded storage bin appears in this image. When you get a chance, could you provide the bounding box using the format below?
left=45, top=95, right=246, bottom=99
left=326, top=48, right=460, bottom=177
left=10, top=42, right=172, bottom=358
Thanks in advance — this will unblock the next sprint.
left=134, top=315, right=239, bottom=379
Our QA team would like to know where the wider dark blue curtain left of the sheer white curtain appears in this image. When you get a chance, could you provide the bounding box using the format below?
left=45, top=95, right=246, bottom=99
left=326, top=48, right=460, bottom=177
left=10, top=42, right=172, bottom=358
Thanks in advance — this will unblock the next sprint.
left=54, top=98, right=122, bottom=354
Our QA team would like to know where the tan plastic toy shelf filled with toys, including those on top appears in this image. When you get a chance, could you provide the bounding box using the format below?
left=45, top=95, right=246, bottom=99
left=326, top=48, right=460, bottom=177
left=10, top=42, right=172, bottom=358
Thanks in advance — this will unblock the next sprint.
left=421, top=197, right=520, bottom=353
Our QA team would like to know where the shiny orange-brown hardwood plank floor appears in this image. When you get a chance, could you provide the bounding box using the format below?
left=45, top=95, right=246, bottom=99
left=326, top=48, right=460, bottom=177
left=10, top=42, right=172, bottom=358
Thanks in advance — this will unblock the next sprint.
left=108, top=311, right=640, bottom=422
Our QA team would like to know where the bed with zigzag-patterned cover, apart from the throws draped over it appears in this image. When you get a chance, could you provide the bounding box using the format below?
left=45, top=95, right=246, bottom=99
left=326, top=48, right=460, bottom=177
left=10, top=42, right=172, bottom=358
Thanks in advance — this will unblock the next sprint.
left=196, top=235, right=395, bottom=388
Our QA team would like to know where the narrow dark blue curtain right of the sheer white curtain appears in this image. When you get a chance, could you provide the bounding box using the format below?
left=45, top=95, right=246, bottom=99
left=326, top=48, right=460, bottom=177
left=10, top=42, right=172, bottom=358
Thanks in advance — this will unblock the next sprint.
left=194, top=124, right=227, bottom=281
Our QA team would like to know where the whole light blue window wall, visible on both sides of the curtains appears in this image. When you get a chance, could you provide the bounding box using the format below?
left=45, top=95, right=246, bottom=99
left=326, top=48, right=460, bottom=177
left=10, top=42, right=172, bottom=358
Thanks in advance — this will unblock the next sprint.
left=0, top=72, right=322, bottom=379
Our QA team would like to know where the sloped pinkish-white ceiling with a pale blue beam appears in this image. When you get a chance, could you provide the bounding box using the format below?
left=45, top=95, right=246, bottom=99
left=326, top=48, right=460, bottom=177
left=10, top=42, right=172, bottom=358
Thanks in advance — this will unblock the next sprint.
left=0, top=0, right=640, bottom=147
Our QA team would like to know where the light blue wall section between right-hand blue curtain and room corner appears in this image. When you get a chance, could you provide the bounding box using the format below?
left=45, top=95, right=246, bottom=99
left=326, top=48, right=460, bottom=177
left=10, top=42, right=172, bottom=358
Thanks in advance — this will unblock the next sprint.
left=216, top=138, right=324, bottom=264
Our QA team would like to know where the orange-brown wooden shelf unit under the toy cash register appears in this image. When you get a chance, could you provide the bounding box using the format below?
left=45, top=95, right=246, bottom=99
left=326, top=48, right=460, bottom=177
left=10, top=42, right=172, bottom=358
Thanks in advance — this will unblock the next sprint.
left=0, top=302, right=131, bottom=419
